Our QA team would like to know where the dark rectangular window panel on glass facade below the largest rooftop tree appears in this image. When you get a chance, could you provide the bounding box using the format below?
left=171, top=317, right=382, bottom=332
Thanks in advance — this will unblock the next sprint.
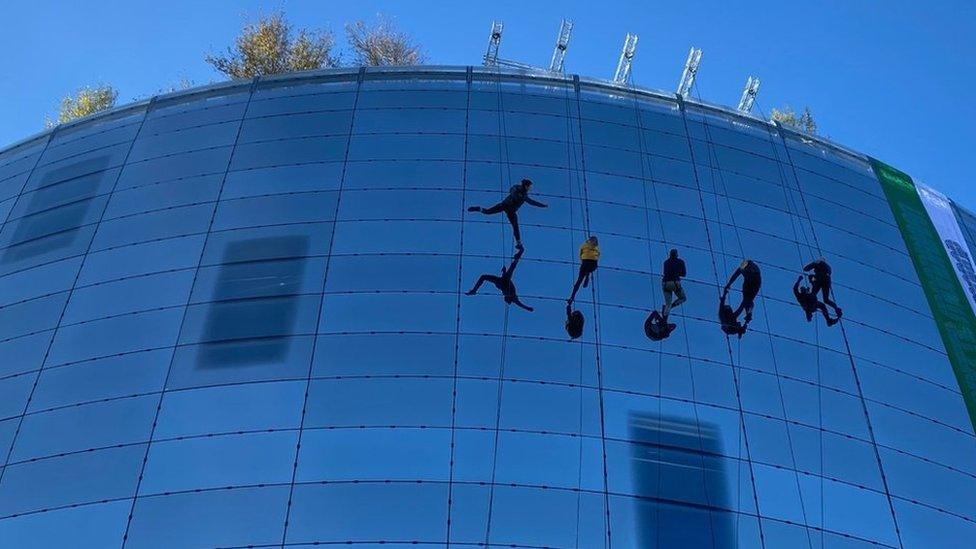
left=197, top=236, right=309, bottom=368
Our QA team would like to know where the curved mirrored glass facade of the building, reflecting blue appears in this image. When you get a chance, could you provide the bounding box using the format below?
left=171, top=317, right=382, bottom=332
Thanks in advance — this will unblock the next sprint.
left=0, top=67, right=976, bottom=549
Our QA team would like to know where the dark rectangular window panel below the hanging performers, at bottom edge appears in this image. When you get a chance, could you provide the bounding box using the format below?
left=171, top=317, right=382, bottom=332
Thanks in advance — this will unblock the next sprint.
left=628, top=412, right=737, bottom=549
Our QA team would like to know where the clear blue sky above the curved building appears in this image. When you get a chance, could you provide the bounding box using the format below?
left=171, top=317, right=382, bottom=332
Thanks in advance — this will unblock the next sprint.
left=0, top=0, right=976, bottom=208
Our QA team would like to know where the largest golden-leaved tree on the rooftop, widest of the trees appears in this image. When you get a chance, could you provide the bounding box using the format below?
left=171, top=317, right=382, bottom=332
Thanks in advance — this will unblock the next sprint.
left=205, top=11, right=339, bottom=78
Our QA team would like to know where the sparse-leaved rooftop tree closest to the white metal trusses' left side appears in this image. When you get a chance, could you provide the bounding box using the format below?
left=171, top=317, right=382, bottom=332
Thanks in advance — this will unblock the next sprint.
left=346, top=16, right=425, bottom=67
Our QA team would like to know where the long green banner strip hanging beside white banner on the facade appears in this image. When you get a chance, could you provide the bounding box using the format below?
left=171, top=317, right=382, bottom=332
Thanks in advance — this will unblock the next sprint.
left=871, top=158, right=976, bottom=428
